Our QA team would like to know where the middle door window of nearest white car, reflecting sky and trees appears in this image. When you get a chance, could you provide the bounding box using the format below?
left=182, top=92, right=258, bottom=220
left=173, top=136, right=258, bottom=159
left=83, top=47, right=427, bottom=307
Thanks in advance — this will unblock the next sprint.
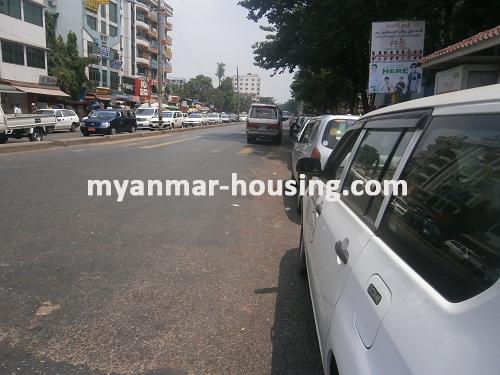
left=343, top=129, right=413, bottom=222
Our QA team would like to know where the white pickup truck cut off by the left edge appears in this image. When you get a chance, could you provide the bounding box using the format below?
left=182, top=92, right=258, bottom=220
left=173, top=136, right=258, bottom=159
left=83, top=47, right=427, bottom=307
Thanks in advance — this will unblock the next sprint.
left=0, top=105, right=56, bottom=143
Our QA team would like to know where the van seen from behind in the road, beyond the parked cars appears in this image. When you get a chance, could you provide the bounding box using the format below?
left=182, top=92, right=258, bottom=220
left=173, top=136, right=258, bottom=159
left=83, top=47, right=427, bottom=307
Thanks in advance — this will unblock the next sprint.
left=246, top=104, right=282, bottom=144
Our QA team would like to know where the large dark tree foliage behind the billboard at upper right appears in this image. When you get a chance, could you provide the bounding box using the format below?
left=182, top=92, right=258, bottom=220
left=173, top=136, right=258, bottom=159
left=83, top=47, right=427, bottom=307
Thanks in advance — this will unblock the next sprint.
left=239, top=0, right=500, bottom=111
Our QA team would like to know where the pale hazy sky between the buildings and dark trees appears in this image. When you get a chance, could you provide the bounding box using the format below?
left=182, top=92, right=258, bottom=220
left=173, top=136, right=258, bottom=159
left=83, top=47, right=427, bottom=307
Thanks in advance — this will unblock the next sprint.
left=167, top=0, right=292, bottom=102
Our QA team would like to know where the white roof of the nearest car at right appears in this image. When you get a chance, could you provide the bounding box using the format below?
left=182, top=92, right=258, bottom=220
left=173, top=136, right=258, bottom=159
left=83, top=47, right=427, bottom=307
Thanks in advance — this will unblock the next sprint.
left=362, top=84, right=500, bottom=118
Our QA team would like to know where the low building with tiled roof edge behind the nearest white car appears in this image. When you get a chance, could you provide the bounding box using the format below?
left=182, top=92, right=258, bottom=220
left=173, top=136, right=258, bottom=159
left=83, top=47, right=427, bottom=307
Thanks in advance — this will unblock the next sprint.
left=419, top=25, right=500, bottom=96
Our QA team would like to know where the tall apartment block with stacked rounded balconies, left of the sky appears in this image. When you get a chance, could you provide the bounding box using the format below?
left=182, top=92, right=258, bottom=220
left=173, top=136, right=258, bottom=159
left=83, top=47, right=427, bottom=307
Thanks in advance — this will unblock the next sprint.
left=123, top=0, right=173, bottom=101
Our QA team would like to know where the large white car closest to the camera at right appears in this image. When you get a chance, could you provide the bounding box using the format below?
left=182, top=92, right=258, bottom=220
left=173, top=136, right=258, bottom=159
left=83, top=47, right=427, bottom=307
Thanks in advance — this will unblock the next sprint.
left=297, top=84, right=500, bottom=375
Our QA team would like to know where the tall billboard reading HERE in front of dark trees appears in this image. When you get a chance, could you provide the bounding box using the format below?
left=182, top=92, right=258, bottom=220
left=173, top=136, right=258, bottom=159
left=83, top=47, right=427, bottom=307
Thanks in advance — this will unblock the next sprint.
left=368, top=21, right=425, bottom=95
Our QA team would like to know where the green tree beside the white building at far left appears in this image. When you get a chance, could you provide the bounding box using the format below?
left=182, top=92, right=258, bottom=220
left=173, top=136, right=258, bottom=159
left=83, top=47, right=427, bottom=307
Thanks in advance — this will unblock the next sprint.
left=45, top=12, right=88, bottom=100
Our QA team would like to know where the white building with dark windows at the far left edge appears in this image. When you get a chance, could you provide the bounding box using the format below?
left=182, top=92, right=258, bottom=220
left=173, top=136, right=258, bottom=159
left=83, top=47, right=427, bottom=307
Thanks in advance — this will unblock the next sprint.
left=0, top=0, right=69, bottom=113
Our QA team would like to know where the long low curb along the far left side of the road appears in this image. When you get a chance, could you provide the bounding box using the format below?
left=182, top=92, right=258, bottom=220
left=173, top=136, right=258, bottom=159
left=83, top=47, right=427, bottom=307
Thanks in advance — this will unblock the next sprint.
left=0, top=123, right=232, bottom=154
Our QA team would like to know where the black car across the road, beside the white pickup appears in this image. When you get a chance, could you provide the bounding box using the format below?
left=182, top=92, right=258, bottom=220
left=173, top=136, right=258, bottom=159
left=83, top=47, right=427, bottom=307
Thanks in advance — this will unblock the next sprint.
left=80, top=109, right=137, bottom=137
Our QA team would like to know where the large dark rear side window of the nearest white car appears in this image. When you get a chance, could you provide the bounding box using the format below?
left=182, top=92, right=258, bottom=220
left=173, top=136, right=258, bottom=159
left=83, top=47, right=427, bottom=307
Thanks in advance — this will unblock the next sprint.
left=380, top=115, right=500, bottom=302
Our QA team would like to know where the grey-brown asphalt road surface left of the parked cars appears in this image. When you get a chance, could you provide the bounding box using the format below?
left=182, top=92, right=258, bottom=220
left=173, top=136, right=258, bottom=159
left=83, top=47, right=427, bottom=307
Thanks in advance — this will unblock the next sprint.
left=0, top=125, right=322, bottom=375
